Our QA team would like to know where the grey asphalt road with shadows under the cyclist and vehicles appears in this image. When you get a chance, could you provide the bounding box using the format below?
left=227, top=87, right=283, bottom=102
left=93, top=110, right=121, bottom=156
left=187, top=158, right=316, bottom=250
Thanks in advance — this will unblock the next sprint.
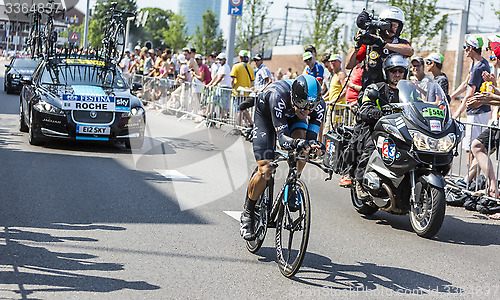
left=0, top=63, right=500, bottom=299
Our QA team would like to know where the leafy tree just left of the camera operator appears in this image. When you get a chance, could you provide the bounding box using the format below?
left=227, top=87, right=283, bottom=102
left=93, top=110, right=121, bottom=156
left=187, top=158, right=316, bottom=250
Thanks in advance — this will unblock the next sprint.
left=305, top=0, right=342, bottom=52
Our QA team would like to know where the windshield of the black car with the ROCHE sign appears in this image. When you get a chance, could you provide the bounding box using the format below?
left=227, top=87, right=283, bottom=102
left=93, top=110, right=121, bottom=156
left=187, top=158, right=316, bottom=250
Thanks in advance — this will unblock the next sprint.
left=42, top=64, right=127, bottom=88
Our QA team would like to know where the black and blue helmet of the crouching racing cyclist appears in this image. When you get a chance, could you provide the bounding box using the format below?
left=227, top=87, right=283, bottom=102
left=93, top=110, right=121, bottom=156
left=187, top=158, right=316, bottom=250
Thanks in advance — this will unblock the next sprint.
left=291, top=74, right=321, bottom=110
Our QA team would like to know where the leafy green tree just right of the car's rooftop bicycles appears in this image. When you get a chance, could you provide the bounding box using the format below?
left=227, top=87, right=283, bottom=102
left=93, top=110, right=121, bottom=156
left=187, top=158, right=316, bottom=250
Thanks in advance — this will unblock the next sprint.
left=141, top=7, right=174, bottom=47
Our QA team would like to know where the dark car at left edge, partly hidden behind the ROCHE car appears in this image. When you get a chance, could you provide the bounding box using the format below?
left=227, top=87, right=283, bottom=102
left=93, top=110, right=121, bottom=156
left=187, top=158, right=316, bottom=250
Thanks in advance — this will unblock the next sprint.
left=3, top=57, right=40, bottom=94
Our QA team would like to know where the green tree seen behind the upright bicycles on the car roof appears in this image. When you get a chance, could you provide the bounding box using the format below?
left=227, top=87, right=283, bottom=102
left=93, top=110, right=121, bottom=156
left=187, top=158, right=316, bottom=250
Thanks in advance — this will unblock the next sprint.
left=88, top=0, right=141, bottom=47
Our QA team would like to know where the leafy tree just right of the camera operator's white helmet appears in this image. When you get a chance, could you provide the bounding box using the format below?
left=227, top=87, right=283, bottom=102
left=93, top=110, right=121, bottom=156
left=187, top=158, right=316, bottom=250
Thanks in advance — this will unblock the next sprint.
left=389, top=0, right=448, bottom=50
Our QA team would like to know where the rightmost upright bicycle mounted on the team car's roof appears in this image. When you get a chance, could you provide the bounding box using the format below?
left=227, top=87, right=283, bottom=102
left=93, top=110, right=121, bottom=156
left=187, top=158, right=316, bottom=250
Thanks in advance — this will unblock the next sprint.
left=102, top=2, right=136, bottom=64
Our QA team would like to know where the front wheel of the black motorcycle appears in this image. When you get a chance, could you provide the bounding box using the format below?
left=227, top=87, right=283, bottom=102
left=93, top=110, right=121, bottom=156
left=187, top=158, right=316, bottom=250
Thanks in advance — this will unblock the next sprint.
left=410, top=180, right=446, bottom=238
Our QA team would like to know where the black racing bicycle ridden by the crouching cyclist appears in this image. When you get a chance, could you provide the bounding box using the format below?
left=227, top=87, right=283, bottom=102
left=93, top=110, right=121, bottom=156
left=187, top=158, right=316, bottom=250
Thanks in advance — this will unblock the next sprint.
left=245, top=151, right=333, bottom=278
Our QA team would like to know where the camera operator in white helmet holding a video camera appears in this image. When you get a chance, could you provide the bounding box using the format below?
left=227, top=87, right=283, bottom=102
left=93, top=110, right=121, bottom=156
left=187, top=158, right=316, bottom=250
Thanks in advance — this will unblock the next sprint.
left=346, top=7, right=414, bottom=94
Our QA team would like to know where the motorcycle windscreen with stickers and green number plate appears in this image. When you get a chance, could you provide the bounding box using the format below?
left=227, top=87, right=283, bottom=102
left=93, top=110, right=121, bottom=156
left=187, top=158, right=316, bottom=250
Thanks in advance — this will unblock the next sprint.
left=397, top=80, right=452, bottom=134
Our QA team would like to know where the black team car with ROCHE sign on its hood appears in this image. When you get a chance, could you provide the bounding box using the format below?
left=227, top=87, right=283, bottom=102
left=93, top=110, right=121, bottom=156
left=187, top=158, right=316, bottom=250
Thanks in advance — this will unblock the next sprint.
left=19, top=56, right=146, bottom=149
